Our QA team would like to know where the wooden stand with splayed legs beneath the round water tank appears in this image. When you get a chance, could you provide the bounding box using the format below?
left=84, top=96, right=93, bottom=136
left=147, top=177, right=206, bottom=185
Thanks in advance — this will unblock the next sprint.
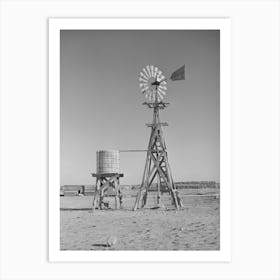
left=91, top=173, right=123, bottom=211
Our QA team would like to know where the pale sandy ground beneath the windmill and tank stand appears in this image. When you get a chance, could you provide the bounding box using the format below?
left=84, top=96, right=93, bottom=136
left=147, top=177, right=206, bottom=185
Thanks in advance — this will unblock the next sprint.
left=60, top=190, right=220, bottom=250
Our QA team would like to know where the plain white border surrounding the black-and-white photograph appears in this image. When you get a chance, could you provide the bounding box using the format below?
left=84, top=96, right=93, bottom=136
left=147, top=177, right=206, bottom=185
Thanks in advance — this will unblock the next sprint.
left=49, top=18, right=231, bottom=262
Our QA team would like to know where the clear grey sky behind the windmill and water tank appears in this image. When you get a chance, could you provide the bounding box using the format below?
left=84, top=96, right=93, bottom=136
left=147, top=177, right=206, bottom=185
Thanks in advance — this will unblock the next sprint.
left=60, top=30, right=220, bottom=185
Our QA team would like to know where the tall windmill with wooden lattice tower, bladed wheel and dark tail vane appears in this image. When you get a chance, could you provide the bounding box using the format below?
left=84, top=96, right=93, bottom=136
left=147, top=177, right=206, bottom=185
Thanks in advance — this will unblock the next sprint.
left=133, top=65, right=185, bottom=210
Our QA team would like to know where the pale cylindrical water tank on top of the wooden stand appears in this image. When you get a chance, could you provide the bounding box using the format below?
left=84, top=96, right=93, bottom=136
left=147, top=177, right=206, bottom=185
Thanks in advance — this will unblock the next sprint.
left=96, top=150, right=120, bottom=174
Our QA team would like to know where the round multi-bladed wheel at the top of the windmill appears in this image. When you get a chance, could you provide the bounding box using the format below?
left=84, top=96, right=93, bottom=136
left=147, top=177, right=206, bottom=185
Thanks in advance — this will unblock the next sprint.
left=139, top=65, right=167, bottom=102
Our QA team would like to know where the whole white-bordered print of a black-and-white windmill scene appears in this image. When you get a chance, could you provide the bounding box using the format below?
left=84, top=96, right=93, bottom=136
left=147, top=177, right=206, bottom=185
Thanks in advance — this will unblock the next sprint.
left=49, top=18, right=231, bottom=262
